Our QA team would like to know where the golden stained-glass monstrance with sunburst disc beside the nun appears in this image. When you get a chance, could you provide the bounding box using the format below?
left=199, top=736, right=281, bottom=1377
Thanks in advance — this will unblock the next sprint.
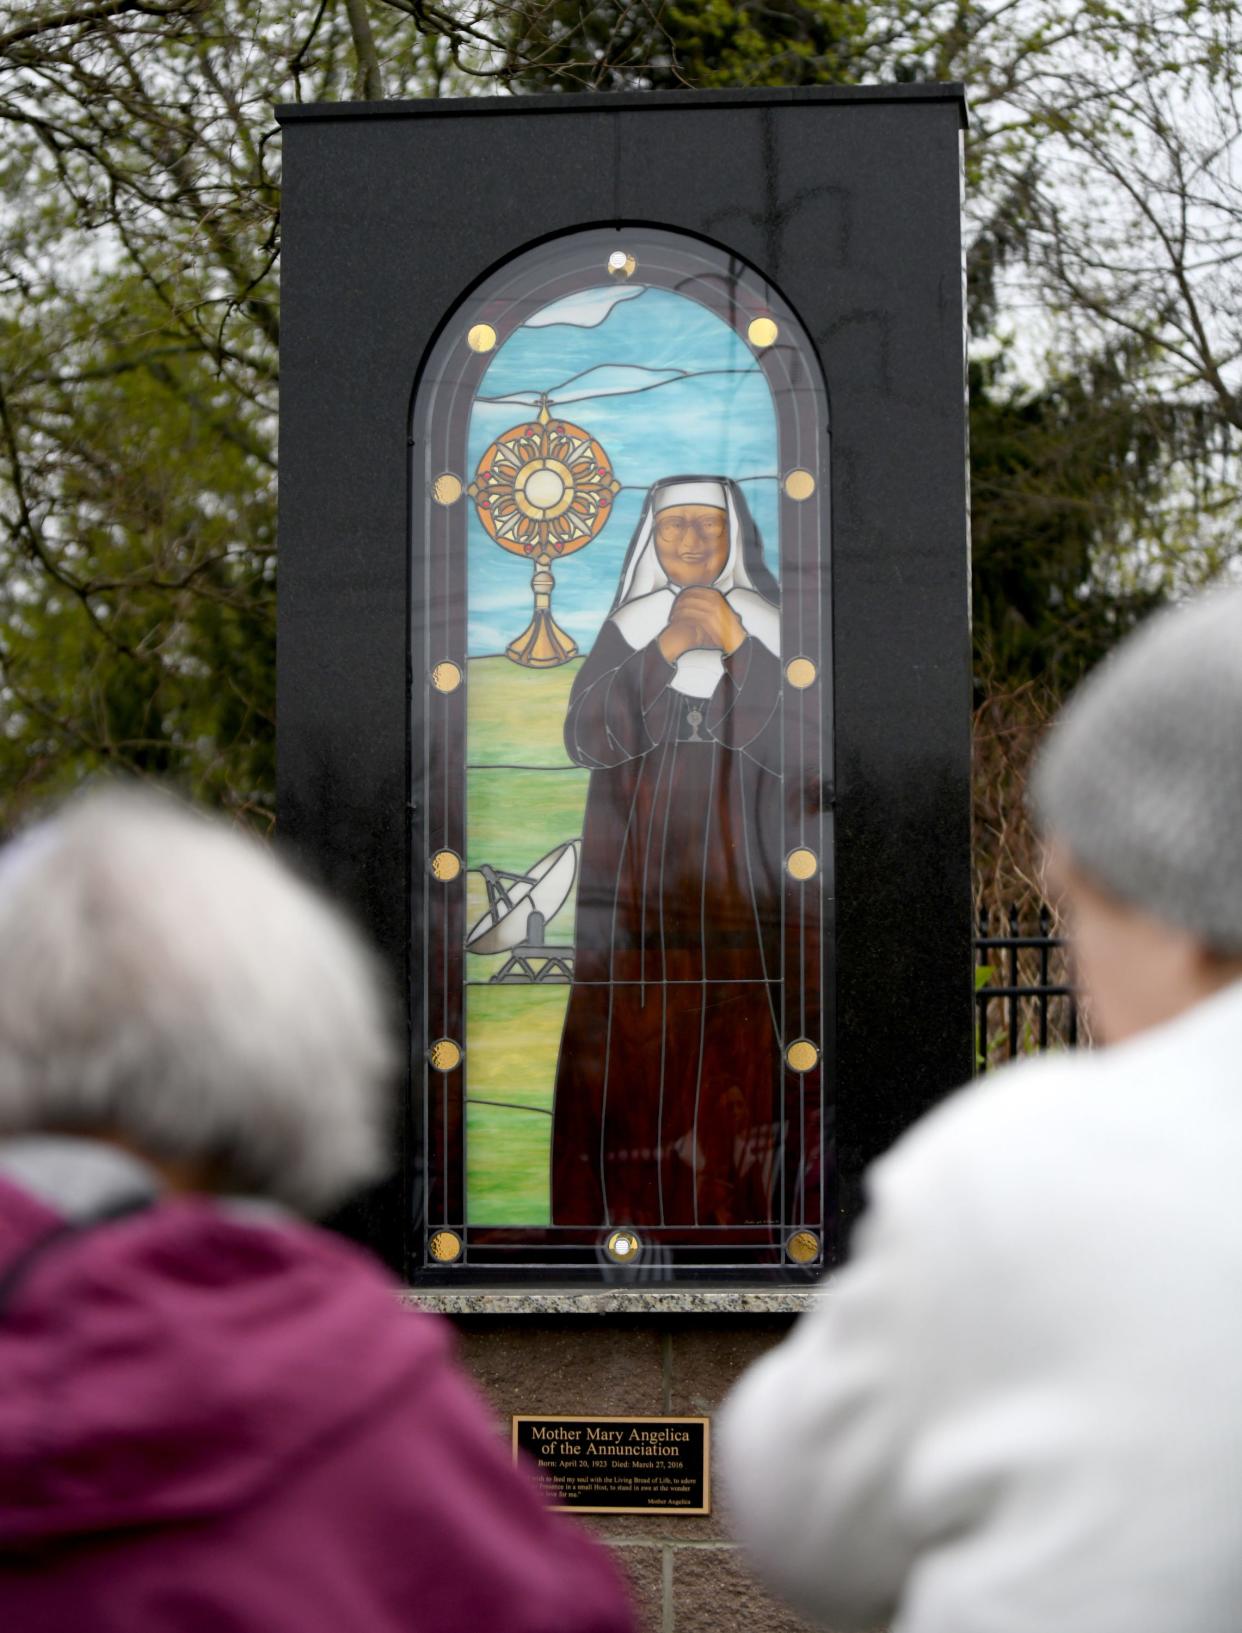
left=467, top=398, right=620, bottom=670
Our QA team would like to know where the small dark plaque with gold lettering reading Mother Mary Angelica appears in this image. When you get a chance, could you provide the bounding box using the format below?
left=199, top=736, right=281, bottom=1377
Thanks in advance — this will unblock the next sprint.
left=512, top=1413, right=712, bottom=1514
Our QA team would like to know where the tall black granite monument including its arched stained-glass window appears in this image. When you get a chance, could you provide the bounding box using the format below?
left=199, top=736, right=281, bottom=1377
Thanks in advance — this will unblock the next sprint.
left=277, top=85, right=973, bottom=1288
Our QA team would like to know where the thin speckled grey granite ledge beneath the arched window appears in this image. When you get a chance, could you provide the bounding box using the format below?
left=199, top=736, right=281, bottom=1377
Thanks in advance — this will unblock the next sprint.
left=400, top=1287, right=823, bottom=1316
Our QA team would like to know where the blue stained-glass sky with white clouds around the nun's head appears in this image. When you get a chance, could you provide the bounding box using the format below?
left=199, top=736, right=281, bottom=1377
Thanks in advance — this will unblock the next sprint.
left=465, top=284, right=778, bottom=656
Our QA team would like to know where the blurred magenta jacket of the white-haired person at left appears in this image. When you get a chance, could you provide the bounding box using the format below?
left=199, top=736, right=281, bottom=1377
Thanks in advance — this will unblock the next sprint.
left=0, top=1177, right=633, bottom=1633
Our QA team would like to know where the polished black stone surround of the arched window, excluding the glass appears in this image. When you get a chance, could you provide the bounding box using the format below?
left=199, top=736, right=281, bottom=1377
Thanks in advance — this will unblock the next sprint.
left=277, top=87, right=973, bottom=1280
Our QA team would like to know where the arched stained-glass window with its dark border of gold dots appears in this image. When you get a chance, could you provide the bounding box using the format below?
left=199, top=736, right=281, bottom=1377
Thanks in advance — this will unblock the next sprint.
left=411, top=227, right=832, bottom=1280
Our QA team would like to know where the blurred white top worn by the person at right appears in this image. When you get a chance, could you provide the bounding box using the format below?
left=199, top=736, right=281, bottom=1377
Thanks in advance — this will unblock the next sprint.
left=718, top=986, right=1242, bottom=1633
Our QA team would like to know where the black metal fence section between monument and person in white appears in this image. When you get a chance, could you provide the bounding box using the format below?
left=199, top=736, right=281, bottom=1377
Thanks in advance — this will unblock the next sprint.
left=974, top=908, right=1079, bottom=1073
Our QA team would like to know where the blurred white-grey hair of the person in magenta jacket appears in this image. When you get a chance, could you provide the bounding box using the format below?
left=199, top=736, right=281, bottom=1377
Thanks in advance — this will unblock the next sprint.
left=0, top=789, right=393, bottom=1215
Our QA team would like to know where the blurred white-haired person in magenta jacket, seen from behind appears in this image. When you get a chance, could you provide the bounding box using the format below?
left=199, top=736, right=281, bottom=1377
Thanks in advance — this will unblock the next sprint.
left=0, top=789, right=632, bottom=1633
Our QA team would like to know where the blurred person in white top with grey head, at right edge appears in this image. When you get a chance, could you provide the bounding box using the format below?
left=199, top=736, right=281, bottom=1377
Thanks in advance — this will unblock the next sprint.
left=718, top=588, right=1242, bottom=1633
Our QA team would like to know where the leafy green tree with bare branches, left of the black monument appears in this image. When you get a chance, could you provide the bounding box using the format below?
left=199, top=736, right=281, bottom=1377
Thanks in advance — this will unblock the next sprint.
left=0, top=0, right=450, bottom=826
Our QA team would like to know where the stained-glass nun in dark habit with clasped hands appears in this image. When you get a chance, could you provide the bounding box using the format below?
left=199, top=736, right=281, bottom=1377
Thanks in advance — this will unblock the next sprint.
left=552, top=477, right=782, bottom=1228
